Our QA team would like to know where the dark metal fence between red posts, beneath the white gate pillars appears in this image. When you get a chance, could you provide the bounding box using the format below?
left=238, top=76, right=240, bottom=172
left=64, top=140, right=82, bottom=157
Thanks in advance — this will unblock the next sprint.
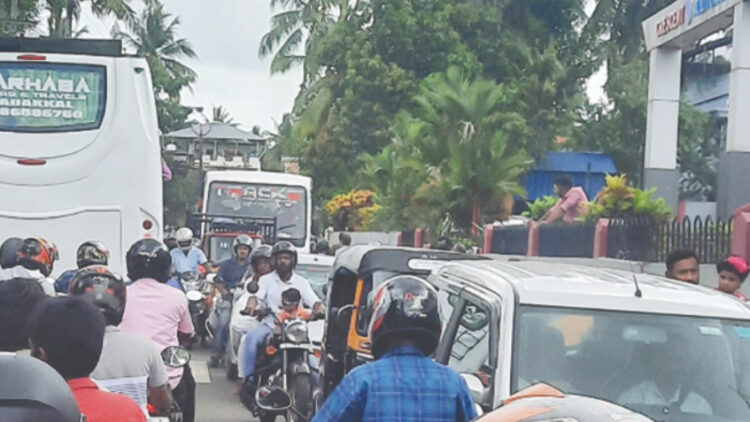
left=607, top=217, right=733, bottom=263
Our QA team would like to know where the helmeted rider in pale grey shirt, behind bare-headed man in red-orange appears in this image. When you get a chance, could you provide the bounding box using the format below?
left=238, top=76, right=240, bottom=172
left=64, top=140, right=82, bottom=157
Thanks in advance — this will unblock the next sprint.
left=68, top=265, right=172, bottom=416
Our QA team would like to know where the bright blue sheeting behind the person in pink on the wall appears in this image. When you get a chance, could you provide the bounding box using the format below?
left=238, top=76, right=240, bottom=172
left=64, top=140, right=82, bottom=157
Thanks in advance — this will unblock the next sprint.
left=524, top=152, right=617, bottom=202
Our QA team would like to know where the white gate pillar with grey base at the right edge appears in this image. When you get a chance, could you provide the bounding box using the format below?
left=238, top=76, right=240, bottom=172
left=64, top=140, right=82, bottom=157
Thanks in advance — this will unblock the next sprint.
left=717, top=2, right=750, bottom=218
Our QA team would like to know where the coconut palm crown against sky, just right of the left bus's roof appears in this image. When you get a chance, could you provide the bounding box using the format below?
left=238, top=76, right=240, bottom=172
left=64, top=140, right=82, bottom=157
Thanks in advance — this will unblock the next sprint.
left=112, top=0, right=197, bottom=84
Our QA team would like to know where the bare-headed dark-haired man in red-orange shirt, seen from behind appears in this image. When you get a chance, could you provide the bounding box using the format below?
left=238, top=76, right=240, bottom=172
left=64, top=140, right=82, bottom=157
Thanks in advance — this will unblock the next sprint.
left=29, top=298, right=146, bottom=422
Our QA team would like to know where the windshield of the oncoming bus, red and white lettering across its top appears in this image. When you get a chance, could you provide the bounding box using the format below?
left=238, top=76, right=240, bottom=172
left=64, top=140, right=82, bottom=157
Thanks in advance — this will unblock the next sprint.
left=206, top=182, right=307, bottom=246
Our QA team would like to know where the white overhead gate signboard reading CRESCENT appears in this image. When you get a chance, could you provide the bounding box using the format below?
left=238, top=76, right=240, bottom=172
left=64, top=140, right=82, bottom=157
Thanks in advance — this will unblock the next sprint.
left=643, top=0, right=743, bottom=50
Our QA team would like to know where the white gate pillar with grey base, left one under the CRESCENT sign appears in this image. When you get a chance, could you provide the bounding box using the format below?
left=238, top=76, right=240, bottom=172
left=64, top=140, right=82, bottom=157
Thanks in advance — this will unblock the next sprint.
left=644, top=47, right=682, bottom=211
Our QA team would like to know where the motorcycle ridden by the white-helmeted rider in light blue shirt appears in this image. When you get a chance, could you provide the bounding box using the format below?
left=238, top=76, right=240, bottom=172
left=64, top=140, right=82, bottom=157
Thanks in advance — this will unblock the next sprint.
left=173, top=271, right=214, bottom=346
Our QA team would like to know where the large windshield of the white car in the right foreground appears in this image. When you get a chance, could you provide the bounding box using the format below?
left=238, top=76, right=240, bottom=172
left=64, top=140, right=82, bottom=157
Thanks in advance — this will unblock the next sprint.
left=512, top=306, right=750, bottom=422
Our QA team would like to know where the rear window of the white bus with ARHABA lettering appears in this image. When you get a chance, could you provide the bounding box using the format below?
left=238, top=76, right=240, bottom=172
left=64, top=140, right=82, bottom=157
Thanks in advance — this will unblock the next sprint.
left=0, top=62, right=106, bottom=132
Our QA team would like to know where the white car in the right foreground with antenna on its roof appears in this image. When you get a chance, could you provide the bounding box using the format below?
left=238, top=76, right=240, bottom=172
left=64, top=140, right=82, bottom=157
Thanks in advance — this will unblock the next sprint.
left=429, top=261, right=750, bottom=422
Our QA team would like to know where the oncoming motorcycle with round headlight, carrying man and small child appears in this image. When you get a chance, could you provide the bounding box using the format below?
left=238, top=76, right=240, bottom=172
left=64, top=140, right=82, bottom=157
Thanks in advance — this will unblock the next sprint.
left=242, top=308, right=321, bottom=422
